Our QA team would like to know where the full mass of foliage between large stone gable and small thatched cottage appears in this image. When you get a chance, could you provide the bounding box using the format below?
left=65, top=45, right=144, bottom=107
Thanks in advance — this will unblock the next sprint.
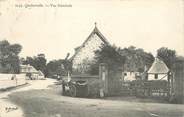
left=87, top=46, right=154, bottom=74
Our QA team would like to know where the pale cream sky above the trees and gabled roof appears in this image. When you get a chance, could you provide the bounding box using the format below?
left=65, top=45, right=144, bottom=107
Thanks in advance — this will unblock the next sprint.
left=0, top=0, right=184, bottom=60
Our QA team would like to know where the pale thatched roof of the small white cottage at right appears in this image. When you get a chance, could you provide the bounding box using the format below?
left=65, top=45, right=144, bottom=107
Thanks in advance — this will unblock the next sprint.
left=148, top=58, right=169, bottom=74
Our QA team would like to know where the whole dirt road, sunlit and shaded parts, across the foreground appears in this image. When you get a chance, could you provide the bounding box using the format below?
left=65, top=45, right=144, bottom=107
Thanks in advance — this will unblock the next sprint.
left=0, top=79, right=184, bottom=117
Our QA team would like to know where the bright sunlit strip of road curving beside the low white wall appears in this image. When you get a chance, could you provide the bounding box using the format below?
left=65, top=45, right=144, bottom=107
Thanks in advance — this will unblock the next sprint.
left=0, top=79, right=55, bottom=117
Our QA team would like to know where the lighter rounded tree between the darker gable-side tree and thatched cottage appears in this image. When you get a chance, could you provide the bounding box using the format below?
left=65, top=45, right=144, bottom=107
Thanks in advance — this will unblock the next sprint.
left=119, top=46, right=154, bottom=72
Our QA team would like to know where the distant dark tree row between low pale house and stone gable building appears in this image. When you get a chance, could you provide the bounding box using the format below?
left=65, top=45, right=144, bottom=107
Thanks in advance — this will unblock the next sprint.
left=21, top=54, right=72, bottom=77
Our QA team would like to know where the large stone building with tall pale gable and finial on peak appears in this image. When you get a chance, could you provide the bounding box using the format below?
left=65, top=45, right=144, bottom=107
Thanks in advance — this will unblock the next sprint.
left=71, top=23, right=109, bottom=73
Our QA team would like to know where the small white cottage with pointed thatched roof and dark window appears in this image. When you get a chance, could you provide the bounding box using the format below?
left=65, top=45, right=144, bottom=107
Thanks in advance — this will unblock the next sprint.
left=147, top=58, right=169, bottom=80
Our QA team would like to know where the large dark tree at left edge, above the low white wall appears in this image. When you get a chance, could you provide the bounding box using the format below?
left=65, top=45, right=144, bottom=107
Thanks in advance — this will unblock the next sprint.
left=0, top=40, right=22, bottom=73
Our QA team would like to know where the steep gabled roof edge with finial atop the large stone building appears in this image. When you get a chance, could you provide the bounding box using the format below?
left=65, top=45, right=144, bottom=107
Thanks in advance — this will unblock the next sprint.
left=70, top=23, right=110, bottom=60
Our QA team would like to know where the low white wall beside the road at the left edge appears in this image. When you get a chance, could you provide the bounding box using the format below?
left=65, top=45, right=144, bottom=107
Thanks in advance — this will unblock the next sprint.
left=0, top=74, right=26, bottom=89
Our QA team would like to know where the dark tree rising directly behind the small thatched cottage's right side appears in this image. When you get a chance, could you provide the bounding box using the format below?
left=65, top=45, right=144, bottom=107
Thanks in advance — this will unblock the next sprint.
left=157, top=47, right=176, bottom=69
